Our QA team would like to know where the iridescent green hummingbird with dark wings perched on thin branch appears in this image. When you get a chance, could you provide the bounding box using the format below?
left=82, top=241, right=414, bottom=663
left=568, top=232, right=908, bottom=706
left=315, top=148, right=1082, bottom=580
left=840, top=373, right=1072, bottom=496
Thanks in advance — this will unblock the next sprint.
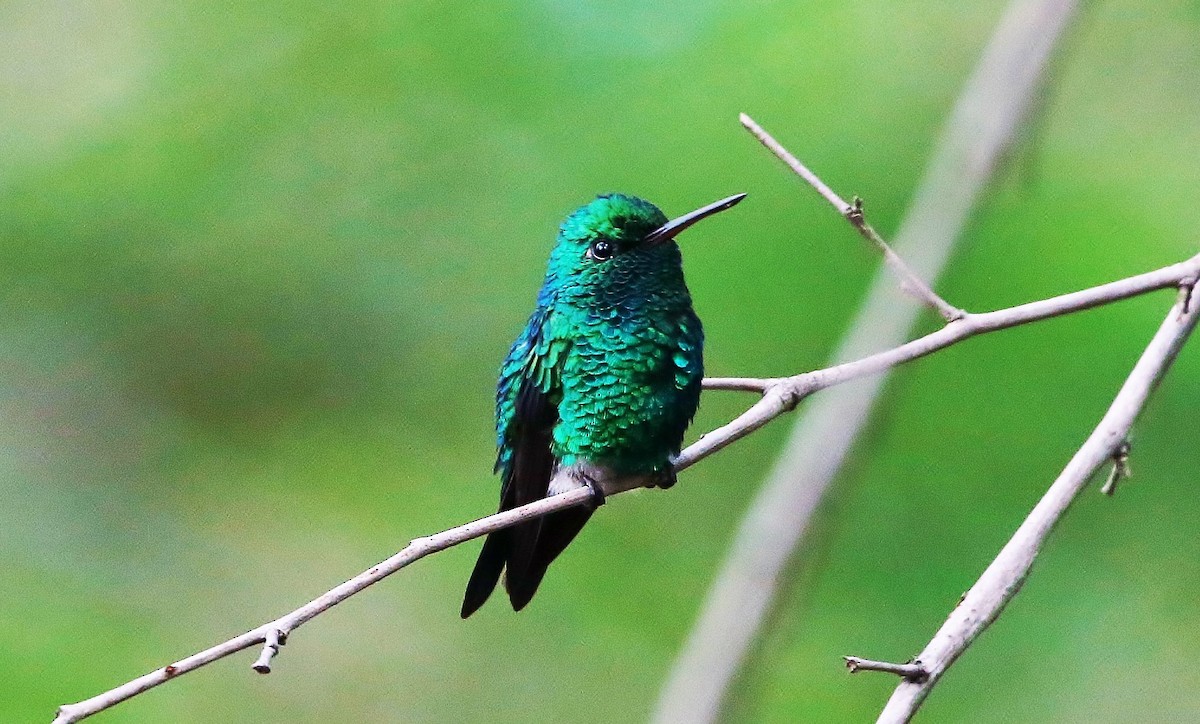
left=462, top=188, right=745, bottom=618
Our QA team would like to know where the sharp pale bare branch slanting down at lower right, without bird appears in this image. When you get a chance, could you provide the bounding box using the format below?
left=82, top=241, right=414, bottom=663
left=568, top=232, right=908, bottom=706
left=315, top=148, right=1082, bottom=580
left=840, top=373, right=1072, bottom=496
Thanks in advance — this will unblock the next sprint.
left=878, top=285, right=1200, bottom=724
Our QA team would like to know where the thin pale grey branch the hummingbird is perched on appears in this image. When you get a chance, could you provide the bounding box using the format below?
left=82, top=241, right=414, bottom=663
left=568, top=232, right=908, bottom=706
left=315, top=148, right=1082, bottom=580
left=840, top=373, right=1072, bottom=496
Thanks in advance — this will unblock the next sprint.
left=54, top=247, right=1200, bottom=724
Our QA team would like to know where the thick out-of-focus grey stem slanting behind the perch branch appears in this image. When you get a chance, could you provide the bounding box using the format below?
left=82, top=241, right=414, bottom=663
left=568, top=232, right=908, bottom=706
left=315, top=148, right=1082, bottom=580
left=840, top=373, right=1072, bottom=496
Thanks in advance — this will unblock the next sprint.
left=654, top=0, right=1075, bottom=724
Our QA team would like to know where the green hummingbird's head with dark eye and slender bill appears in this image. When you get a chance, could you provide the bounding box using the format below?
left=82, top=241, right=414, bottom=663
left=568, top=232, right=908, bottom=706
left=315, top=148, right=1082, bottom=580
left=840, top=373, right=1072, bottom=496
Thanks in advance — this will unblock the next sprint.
left=547, top=193, right=745, bottom=297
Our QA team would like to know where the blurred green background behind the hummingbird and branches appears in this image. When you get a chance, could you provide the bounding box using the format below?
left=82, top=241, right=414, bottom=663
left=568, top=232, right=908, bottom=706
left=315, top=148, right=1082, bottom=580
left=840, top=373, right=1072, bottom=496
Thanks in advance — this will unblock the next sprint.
left=0, top=0, right=1200, bottom=722
